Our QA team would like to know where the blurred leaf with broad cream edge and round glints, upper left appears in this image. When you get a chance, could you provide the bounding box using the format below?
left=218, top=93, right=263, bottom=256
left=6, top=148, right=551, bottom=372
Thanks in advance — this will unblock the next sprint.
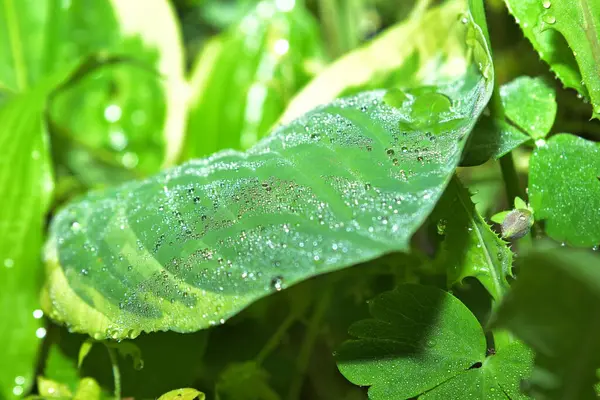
left=42, top=0, right=185, bottom=186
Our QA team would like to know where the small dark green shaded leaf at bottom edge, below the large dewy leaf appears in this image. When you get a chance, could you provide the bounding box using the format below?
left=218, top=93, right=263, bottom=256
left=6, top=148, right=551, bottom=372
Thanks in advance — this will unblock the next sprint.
left=216, top=361, right=280, bottom=400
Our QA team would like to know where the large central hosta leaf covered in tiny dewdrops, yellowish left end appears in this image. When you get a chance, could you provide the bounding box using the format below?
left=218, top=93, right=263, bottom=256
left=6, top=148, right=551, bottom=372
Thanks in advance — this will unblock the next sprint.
left=45, top=24, right=492, bottom=338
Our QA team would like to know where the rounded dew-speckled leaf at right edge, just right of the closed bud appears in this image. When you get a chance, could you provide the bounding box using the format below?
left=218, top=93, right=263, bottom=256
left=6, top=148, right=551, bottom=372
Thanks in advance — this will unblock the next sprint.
left=529, top=134, right=600, bottom=247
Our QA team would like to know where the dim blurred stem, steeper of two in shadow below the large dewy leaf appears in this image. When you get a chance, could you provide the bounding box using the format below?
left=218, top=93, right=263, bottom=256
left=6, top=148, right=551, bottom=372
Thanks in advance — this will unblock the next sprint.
left=287, top=288, right=332, bottom=400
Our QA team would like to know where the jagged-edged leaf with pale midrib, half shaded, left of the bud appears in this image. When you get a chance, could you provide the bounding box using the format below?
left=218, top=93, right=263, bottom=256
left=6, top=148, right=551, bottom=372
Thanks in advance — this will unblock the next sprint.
left=433, top=178, right=512, bottom=301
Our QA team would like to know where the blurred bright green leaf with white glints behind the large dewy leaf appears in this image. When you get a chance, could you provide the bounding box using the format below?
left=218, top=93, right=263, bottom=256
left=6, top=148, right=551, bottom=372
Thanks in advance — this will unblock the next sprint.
left=183, top=0, right=322, bottom=159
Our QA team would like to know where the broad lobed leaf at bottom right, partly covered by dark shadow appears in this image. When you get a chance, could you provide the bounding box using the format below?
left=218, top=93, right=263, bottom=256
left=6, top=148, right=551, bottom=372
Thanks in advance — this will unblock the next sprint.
left=336, top=285, right=532, bottom=400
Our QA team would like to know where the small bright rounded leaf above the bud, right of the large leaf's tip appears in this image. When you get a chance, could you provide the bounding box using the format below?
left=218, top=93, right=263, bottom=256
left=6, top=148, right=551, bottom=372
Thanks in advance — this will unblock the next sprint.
left=500, top=76, right=556, bottom=139
